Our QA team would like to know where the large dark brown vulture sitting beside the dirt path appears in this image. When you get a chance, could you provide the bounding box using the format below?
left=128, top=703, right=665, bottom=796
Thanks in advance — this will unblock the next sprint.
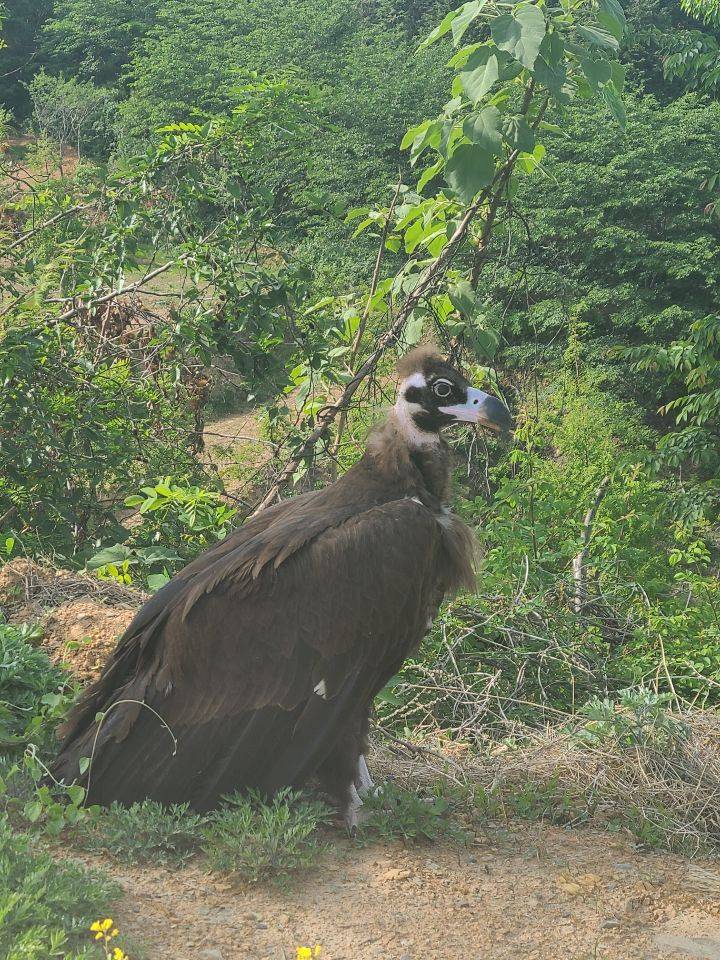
left=51, top=347, right=512, bottom=832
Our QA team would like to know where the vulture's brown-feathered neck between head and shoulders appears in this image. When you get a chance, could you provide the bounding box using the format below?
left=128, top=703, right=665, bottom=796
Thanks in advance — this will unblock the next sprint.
left=367, top=408, right=451, bottom=504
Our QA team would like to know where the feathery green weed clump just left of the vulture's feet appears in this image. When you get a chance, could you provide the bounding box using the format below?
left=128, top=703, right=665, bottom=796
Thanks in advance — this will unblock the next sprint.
left=203, top=790, right=330, bottom=883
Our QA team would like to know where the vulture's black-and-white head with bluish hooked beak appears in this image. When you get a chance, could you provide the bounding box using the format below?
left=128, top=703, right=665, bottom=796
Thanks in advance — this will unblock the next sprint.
left=395, top=347, right=514, bottom=445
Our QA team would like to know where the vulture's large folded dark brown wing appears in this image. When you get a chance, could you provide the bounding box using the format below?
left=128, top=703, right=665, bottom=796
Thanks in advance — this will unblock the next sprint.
left=55, top=499, right=445, bottom=808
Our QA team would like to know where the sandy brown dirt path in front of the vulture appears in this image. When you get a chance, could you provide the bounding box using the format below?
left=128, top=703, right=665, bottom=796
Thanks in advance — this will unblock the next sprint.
left=71, top=825, right=720, bottom=960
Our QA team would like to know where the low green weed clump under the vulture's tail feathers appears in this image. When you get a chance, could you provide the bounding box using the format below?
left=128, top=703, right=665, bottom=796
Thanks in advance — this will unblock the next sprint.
left=80, top=800, right=208, bottom=866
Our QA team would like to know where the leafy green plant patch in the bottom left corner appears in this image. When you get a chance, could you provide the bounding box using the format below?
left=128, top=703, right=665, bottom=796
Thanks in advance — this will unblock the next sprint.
left=0, top=816, right=121, bottom=960
